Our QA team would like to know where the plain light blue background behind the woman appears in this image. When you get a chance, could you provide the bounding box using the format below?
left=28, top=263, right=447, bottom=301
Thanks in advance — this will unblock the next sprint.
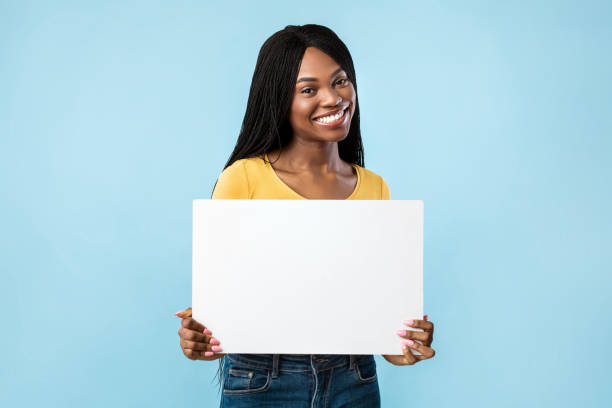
left=0, top=1, right=612, bottom=407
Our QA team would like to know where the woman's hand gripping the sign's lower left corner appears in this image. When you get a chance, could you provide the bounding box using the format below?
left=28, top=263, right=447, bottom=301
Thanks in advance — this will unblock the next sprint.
left=174, top=307, right=225, bottom=361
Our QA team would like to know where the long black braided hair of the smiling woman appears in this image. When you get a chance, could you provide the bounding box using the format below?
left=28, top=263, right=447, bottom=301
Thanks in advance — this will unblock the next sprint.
left=213, top=24, right=364, bottom=198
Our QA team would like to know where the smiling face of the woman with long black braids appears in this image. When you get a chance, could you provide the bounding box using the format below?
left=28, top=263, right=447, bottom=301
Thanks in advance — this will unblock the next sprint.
left=289, top=47, right=356, bottom=142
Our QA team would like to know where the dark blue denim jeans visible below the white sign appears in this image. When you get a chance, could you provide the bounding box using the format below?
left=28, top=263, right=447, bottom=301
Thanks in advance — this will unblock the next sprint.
left=221, top=354, right=380, bottom=408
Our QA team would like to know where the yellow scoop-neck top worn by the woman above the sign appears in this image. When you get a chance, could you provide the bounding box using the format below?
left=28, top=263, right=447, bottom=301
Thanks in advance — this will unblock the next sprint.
left=212, top=154, right=391, bottom=200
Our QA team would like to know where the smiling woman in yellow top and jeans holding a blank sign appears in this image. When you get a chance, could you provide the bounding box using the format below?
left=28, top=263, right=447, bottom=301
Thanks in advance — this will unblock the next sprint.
left=176, top=24, right=435, bottom=408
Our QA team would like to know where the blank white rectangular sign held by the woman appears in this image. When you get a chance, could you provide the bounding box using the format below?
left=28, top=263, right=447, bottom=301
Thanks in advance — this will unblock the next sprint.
left=192, top=199, right=423, bottom=354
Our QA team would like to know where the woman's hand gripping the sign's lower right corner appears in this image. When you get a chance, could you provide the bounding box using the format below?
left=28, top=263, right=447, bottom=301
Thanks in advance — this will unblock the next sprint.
left=383, top=316, right=436, bottom=365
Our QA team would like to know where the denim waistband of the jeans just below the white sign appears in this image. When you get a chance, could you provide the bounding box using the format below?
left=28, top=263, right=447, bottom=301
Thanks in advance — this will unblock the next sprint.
left=227, top=354, right=373, bottom=372
